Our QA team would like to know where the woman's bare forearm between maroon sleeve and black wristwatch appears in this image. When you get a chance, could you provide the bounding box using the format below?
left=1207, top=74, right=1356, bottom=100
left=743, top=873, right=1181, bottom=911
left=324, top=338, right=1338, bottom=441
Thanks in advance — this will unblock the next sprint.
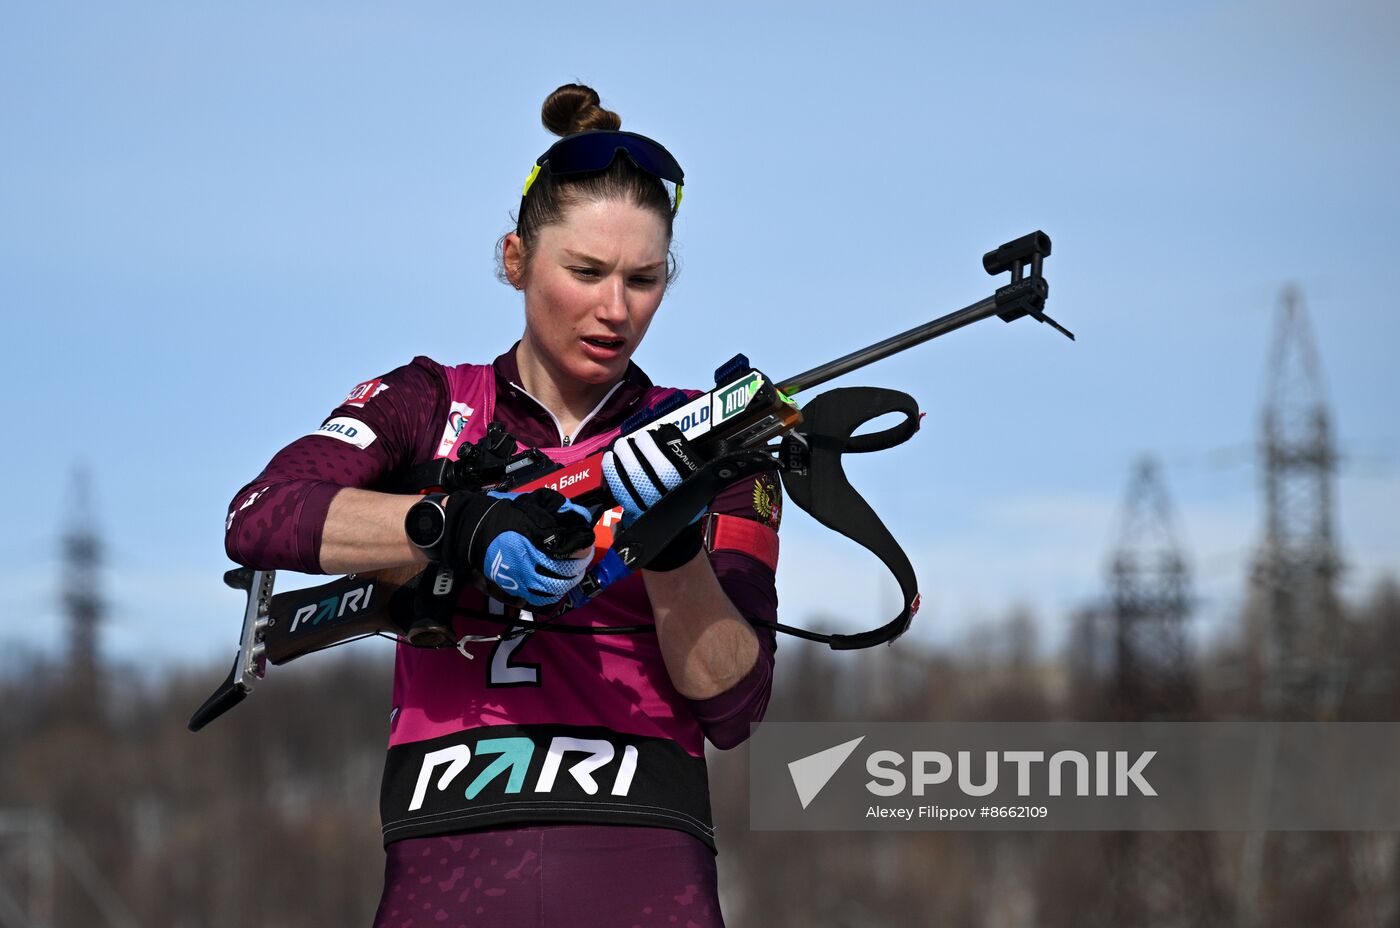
left=321, top=487, right=428, bottom=574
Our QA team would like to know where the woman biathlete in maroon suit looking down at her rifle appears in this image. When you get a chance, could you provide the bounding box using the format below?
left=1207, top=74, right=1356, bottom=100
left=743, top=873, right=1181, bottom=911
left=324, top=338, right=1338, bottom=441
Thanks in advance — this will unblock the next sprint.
left=227, top=84, right=780, bottom=928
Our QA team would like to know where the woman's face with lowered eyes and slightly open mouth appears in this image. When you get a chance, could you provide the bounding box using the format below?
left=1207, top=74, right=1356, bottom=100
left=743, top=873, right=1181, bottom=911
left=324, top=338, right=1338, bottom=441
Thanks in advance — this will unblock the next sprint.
left=505, top=200, right=671, bottom=384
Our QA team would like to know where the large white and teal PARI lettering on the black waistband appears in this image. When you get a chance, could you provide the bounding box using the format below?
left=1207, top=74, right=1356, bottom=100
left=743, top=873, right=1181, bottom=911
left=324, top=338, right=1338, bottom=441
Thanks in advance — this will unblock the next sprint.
left=409, top=736, right=637, bottom=812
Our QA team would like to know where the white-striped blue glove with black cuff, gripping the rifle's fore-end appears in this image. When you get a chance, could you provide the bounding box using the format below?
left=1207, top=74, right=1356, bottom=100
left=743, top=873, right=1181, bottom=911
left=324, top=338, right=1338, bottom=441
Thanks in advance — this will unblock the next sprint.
left=603, top=423, right=704, bottom=571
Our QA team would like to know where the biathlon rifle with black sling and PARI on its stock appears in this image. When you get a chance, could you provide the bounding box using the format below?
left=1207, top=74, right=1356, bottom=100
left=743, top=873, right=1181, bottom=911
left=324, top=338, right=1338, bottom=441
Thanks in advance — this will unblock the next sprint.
left=189, top=231, right=1074, bottom=731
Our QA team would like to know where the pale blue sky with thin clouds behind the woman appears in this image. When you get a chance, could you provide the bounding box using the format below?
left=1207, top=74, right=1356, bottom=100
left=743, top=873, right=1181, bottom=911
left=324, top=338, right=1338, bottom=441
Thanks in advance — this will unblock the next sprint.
left=0, top=0, right=1400, bottom=666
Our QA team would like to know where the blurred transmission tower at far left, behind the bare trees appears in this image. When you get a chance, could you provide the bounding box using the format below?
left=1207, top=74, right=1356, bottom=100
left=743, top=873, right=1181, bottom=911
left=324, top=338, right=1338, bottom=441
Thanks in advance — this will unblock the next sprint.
left=59, top=467, right=106, bottom=714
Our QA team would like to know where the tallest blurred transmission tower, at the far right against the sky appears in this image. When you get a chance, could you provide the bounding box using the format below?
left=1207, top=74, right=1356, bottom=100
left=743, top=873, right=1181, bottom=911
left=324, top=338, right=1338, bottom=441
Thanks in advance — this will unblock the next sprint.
left=1239, top=287, right=1375, bottom=927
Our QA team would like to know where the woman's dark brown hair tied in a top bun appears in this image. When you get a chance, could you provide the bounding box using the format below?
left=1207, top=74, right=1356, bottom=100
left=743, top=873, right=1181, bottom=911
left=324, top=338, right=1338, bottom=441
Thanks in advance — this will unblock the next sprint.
left=496, top=84, right=678, bottom=284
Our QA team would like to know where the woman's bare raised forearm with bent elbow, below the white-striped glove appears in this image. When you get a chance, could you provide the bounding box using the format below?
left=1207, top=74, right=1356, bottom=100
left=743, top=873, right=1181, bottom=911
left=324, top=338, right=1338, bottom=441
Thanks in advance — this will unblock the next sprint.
left=641, top=550, right=759, bottom=700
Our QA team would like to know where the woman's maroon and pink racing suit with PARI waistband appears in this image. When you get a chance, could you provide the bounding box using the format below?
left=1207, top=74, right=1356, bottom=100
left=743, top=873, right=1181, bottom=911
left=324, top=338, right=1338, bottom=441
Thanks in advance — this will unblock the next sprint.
left=227, top=349, right=781, bottom=925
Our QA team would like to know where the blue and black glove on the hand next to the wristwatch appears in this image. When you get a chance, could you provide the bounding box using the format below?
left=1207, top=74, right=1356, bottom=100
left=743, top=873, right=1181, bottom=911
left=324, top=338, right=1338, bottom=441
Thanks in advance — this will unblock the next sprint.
left=442, top=490, right=594, bottom=606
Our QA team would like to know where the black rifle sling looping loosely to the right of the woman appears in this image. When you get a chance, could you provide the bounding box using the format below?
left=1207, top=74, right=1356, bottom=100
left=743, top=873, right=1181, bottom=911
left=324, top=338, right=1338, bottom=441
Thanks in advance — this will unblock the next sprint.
left=756, top=386, right=918, bottom=651
